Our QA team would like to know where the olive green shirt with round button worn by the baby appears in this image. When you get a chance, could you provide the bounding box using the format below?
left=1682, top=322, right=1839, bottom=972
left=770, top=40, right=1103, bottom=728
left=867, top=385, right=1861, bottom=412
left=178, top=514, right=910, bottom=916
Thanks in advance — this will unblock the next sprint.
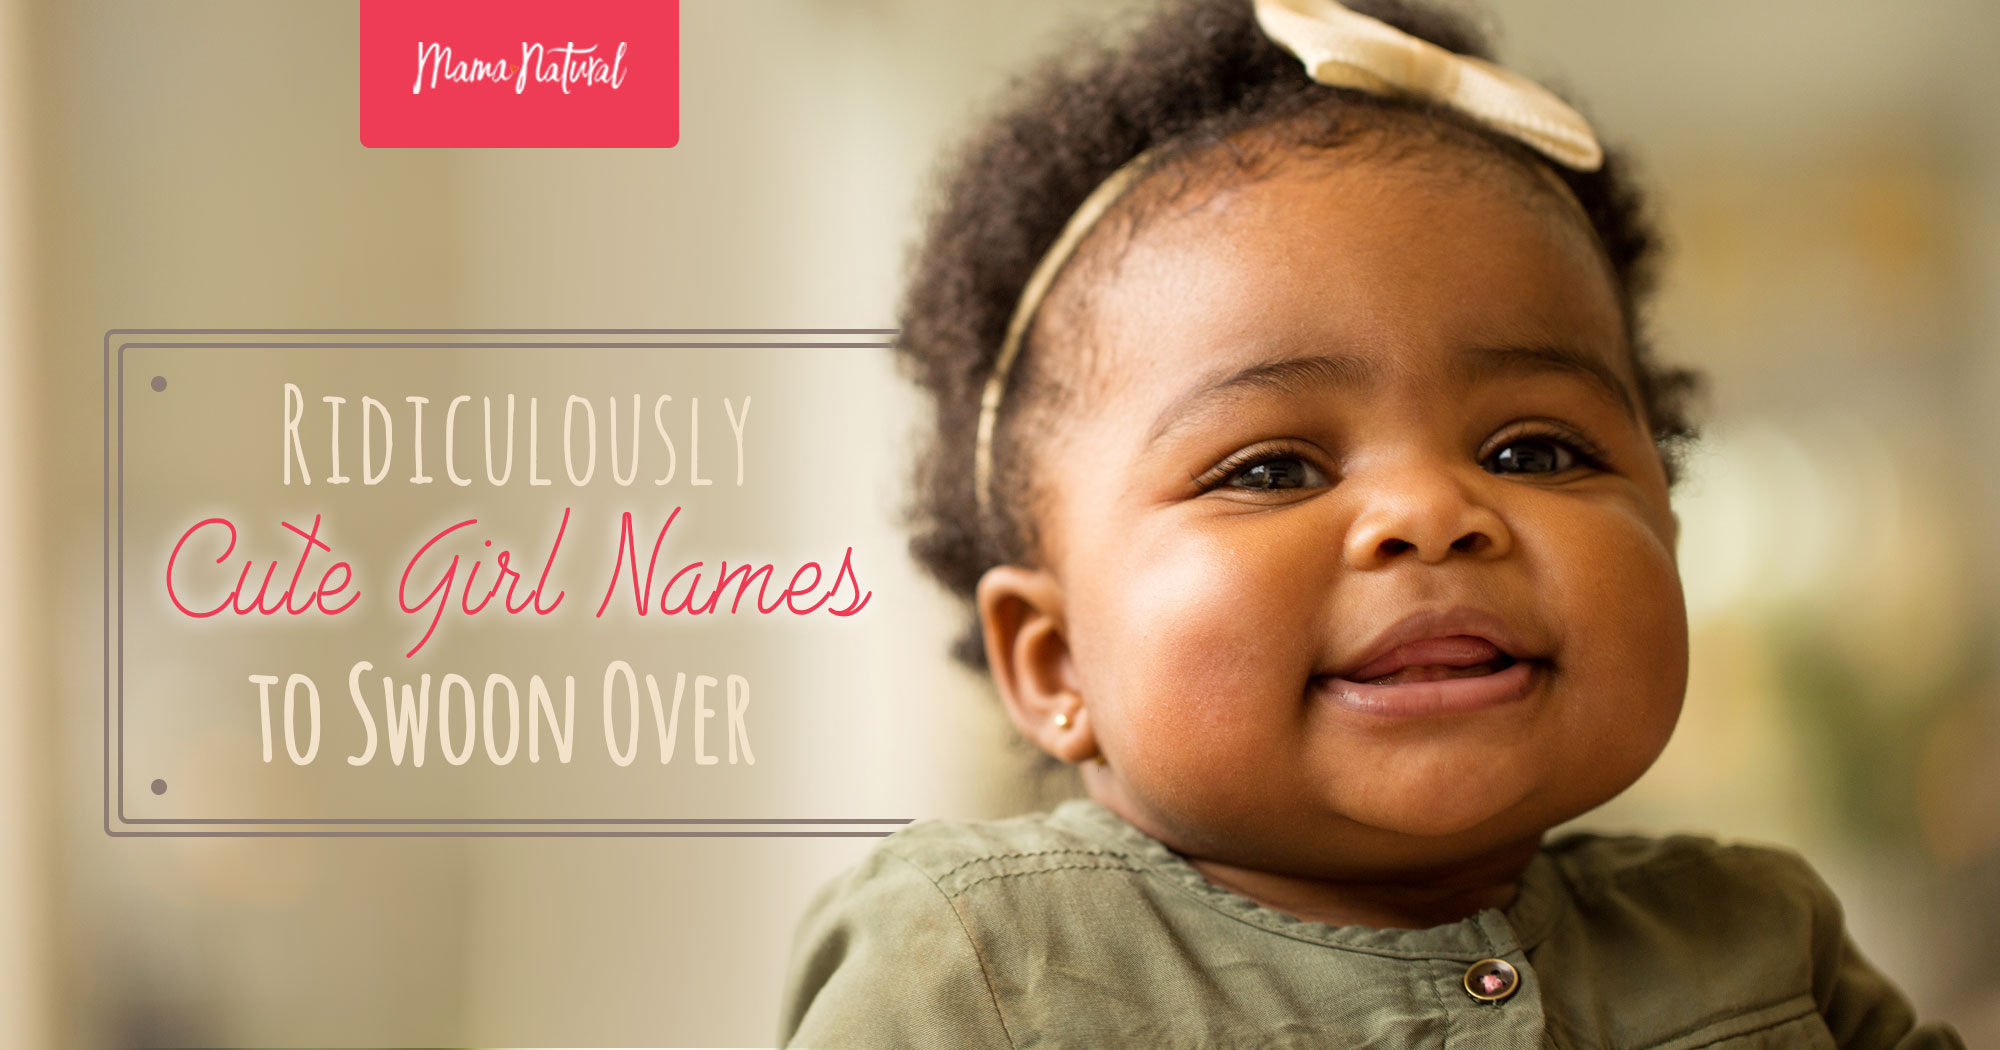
left=778, top=800, right=1964, bottom=1050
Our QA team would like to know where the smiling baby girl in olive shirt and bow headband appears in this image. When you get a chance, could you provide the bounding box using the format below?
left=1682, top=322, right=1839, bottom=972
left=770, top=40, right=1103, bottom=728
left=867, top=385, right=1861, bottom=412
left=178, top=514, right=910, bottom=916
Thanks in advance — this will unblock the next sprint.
left=780, top=0, right=1962, bottom=1050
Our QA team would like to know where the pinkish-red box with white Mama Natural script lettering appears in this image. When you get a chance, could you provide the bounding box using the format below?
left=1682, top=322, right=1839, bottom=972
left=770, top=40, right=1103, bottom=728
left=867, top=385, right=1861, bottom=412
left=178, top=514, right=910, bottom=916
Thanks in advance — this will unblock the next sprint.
left=360, top=0, right=680, bottom=148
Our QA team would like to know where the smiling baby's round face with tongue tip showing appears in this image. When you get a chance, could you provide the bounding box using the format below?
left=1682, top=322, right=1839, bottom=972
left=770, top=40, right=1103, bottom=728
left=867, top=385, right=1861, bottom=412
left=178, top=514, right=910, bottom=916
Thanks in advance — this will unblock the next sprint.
left=982, top=147, right=1688, bottom=878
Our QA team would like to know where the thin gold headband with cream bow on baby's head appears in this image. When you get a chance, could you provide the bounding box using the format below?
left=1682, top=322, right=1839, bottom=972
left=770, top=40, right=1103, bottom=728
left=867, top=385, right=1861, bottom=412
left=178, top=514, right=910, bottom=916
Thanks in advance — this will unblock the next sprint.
left=972, top=0, right=1604, bottom=518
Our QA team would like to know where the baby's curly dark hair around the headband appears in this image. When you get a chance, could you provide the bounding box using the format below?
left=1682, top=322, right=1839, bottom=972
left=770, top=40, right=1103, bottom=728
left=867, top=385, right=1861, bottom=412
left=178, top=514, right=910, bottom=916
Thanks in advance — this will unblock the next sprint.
left=898, top=0, right=1704, bottom=670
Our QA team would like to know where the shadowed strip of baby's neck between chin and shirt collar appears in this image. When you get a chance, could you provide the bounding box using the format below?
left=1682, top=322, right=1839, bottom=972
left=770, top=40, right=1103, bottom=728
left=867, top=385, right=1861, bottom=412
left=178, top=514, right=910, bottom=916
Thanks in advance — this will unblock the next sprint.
left=1188, top=840, right=1540, bottom=930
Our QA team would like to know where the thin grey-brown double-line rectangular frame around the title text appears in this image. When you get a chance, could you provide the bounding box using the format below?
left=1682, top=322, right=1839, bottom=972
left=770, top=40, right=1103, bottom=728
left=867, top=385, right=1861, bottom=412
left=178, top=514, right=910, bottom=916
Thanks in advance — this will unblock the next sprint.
left=104, top=328, right=914, bottom=838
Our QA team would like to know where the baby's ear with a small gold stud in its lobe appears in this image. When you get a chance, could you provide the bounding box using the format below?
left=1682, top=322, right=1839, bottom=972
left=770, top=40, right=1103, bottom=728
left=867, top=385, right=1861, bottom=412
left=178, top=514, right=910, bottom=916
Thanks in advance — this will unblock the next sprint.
left=976, top=566, right=1098, bottom=762
